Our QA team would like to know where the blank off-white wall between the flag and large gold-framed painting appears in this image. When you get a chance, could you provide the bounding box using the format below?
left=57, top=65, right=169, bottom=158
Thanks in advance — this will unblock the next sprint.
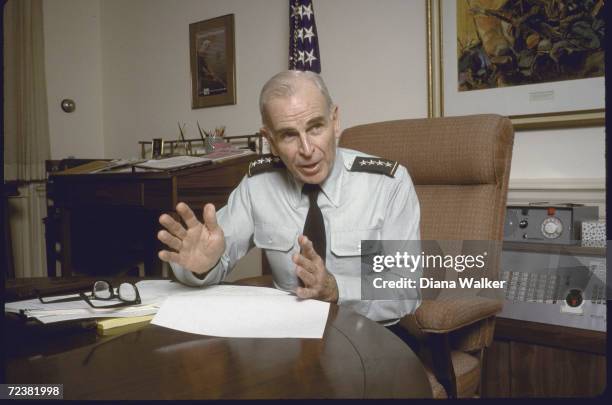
left=310, top=0, right=427, bottom=124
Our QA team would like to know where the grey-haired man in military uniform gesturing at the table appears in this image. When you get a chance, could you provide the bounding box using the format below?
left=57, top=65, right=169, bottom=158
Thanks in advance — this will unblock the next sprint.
left=158, top=71, right=420, bottom=324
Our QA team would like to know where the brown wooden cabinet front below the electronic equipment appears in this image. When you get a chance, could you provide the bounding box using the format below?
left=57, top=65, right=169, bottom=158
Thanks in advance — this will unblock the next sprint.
left=483, top=318, right=607, bottom=398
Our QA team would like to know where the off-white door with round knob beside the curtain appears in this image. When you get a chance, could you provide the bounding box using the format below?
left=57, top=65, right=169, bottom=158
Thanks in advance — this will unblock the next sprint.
left=43, top=0, right=104, bottom=159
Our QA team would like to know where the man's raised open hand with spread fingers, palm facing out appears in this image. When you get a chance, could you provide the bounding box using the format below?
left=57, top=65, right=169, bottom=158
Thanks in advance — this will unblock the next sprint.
left=157, top=202, right=225, bottom=274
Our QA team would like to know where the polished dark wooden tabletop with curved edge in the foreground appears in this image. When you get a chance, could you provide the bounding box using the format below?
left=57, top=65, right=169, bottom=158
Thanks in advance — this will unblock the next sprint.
left=5, top=276, right=431, bottom=399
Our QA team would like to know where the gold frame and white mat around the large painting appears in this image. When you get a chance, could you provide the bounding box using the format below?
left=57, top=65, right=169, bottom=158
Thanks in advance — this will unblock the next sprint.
left=425, top=0, right=605, bottom=131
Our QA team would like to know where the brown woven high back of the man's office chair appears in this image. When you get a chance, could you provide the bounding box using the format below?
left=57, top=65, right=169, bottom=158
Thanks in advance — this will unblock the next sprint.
left=340, top=114, right=514, bottom=241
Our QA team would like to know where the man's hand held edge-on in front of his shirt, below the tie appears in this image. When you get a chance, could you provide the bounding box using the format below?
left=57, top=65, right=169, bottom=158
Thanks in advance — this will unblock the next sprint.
left=293, top=235, right=338, bottom=302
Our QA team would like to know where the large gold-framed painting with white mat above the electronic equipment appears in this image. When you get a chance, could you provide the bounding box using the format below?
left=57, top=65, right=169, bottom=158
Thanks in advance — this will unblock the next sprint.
left=426, top=0, right=605, bottom=130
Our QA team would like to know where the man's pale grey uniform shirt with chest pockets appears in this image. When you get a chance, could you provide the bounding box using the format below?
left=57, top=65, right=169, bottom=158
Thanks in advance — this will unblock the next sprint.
left=170, top=148, right=420, bottom=322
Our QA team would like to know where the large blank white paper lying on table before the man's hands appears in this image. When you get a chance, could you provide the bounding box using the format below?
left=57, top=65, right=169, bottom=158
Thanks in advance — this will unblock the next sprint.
left=151, top=286, right=329, bottom=339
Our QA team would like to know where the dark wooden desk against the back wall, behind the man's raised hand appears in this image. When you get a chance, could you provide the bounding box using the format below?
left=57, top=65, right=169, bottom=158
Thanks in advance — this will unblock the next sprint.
left=46, top=155, right=251, bottom=277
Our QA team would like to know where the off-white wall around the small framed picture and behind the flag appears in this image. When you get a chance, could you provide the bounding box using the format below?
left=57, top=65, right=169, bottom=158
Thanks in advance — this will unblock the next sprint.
left=94, top=0, right=426, bottom=157
